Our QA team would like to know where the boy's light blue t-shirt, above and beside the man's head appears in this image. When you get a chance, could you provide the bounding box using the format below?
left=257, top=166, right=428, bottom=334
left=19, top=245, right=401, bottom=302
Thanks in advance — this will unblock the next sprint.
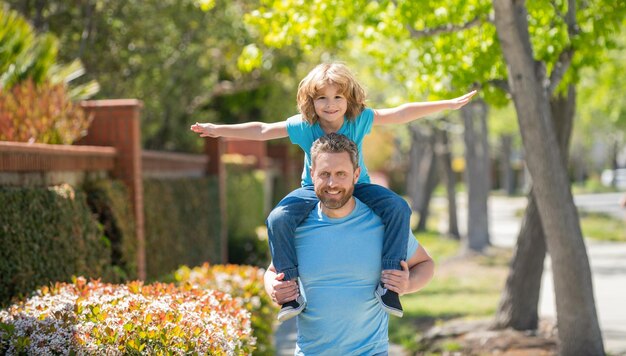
left=287, top=108, right=374, bottom=187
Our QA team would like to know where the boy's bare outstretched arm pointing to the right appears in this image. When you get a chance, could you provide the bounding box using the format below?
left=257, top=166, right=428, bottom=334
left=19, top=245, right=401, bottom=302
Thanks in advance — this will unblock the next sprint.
left=374, top=90, right=476, bottom=125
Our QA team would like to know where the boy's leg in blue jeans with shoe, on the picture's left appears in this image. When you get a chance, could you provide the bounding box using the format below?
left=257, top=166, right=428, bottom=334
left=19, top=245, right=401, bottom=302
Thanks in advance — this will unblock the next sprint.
left=266, top=187, right=318, bottom=321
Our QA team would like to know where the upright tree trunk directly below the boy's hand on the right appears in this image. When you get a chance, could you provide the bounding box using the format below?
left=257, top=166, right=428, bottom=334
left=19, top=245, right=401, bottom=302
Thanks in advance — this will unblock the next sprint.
left=461, top=100, right=491, bottom=252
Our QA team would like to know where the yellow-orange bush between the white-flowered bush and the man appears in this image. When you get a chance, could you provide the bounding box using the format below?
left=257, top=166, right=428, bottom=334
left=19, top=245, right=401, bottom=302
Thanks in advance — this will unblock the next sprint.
left=174, top=263, right=277, bottom=356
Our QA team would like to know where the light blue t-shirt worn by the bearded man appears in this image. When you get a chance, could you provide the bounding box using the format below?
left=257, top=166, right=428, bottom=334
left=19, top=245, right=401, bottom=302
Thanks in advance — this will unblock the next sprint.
left=295, top=198, right=418, bottom=355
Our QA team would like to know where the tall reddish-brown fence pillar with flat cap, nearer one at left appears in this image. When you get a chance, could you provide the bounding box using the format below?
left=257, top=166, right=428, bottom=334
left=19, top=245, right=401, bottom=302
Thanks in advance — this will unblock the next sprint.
left=78, top=99, right=146, bottom=280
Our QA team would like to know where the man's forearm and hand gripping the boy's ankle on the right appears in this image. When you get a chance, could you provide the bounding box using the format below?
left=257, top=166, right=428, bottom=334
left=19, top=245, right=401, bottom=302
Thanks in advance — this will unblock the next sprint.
left=380, top=245, right=435, bottom=295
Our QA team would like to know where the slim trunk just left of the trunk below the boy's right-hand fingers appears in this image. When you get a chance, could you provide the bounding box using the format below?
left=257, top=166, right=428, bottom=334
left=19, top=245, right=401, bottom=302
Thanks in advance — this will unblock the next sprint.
left=435, top=128, right=461, bottom=240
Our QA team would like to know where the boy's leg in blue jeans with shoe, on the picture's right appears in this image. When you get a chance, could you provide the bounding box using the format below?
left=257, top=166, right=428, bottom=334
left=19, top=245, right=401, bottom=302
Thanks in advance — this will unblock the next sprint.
left=354, top=183, right=411, bottom=316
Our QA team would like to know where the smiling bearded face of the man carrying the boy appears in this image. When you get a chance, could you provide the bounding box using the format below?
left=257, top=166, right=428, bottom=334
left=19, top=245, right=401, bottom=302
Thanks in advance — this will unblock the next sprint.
left=311, top=152, right=361, bottom=209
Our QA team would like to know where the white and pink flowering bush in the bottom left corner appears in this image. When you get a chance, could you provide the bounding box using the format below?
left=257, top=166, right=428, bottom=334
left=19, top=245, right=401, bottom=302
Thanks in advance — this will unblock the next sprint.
left=0, top=278, right=255, bottom=355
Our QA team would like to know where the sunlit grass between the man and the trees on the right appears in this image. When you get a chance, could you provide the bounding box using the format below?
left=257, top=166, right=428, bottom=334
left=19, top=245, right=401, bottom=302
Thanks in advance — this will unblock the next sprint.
left=389, top=233, right=511, bottom=352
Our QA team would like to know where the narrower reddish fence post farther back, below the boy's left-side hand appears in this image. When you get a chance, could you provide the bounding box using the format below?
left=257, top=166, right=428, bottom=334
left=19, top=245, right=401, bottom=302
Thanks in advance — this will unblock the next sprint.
left=204, top=137, right=228, bottom=263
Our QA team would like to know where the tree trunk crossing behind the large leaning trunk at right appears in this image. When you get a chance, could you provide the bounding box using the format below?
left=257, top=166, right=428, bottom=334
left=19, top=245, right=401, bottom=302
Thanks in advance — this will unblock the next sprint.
left=493, top=85, right=576, bottom=330
